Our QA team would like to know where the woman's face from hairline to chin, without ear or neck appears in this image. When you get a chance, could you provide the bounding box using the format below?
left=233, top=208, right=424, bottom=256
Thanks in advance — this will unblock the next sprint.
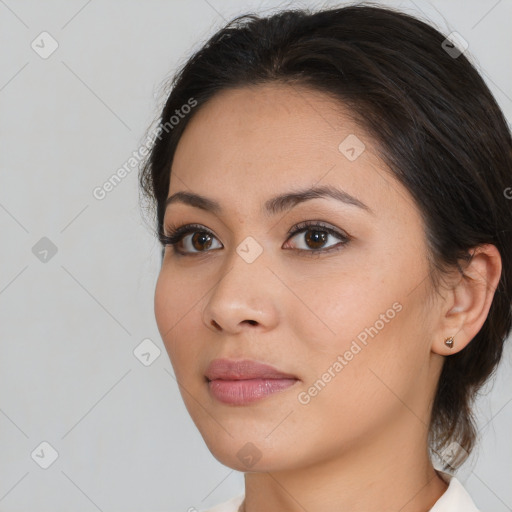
left=155, top=84, right=442, bottom=471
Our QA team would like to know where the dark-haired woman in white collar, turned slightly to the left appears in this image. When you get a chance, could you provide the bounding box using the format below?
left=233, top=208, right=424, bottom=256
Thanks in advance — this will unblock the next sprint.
left=140, top=6, right=512, bottom=512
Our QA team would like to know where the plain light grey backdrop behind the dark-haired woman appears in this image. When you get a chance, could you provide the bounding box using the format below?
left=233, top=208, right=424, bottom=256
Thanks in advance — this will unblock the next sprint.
left=0, top=0, right=512, bottom=512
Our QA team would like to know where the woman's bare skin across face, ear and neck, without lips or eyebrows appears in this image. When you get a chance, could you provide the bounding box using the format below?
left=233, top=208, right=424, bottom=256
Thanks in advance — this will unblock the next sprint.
left=155, top=84, right=501, bottom=512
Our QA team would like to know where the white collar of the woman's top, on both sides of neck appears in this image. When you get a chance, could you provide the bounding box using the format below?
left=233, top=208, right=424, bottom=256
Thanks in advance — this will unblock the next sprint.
left=204, top=470, right=480, bottom=512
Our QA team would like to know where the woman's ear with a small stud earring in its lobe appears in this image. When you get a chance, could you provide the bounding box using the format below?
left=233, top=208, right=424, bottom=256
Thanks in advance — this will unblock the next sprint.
left=432, top=244, right=502, bottom=356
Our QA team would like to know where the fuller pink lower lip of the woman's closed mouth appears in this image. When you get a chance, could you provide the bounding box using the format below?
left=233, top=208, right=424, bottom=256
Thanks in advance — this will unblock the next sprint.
left=208, top=379, right=298, bottom=405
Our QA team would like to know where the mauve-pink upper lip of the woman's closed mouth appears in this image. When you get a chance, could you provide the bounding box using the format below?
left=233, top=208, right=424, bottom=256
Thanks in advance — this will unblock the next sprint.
left=205, top=359, right=297, bottom=380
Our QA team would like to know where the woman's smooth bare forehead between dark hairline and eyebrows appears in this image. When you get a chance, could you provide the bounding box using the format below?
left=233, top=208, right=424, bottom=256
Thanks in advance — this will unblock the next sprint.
left=168, top=84, right=414, bottom=222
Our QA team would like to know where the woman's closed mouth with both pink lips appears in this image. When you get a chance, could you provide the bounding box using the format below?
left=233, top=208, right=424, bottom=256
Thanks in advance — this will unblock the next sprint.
left=205, top=359, right=299, bottom=405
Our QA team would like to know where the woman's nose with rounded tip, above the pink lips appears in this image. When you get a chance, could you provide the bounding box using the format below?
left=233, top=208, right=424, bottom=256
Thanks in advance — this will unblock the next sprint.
left=202, top=252, right=279, bottom=334
